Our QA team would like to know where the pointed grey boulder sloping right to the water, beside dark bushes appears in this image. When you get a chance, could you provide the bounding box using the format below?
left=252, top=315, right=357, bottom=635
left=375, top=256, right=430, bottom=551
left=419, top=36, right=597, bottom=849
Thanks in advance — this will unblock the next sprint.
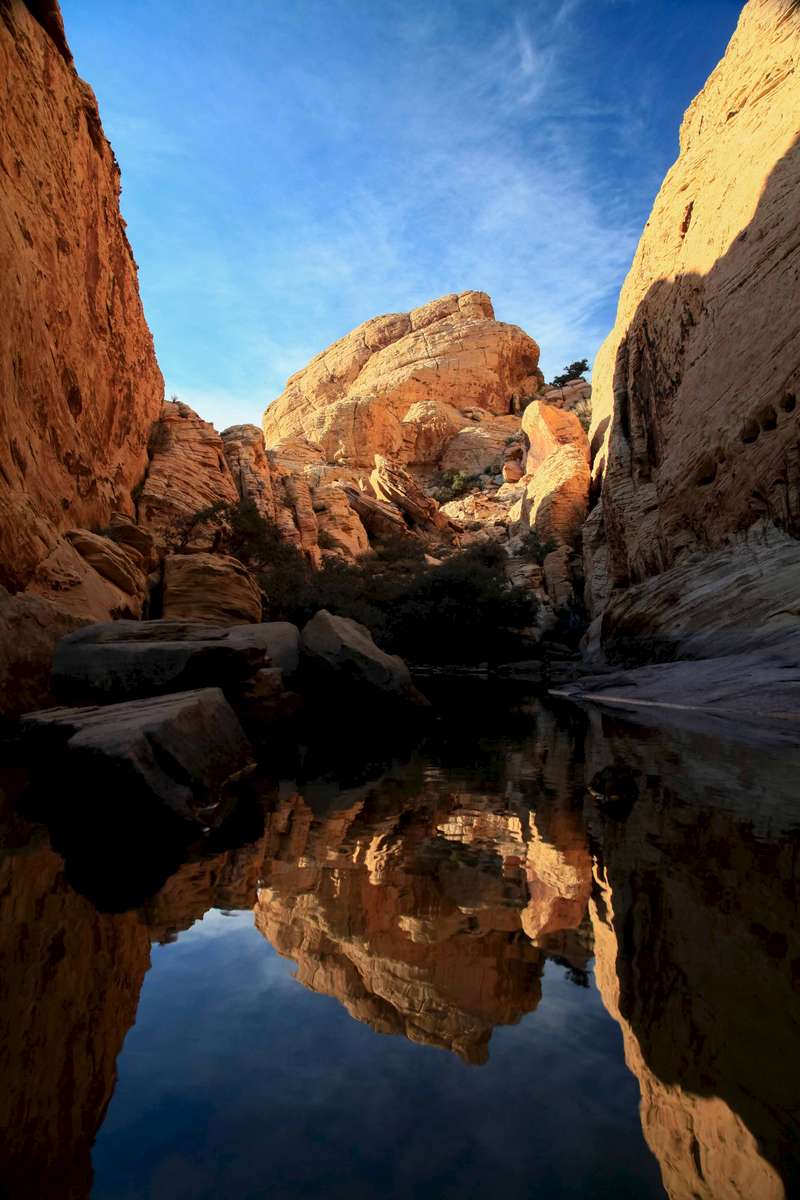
left=300, top=608, right=427, bottom=706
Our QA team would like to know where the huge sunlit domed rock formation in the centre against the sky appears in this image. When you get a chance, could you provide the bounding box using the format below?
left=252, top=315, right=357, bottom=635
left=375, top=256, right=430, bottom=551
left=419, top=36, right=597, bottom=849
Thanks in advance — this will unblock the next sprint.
left=264, top=292, right=541, bottom=467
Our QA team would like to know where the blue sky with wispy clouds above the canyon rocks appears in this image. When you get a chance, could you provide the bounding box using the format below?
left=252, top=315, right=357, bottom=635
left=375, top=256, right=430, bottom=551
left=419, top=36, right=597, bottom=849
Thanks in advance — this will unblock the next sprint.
left=62, top=0, right=741, bottom=428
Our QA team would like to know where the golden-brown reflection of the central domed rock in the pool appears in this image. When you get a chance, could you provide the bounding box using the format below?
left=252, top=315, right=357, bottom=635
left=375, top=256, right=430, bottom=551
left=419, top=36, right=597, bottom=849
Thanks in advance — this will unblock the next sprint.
left=255, top=748, right=590, bottom=1063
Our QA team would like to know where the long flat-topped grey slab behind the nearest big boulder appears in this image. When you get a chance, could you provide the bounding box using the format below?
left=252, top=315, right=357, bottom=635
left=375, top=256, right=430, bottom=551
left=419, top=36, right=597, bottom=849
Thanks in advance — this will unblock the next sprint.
left=53, top=620, right=300, bottom=704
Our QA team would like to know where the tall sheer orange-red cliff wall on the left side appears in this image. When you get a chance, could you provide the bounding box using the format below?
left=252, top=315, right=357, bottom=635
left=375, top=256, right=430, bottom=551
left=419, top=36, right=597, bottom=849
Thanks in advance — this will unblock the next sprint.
left=0, top=0, right=163, bottom=590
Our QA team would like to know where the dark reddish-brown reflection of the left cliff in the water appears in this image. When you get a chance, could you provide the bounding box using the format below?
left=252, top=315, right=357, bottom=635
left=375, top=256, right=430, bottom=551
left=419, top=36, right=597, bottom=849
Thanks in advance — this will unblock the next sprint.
left=0, top=848, right=150, bottom=1200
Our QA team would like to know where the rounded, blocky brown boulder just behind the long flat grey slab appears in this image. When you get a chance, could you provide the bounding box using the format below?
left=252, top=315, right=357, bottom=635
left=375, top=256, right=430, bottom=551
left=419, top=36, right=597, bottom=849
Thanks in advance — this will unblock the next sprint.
left=163, top=553, right=261, bottom=625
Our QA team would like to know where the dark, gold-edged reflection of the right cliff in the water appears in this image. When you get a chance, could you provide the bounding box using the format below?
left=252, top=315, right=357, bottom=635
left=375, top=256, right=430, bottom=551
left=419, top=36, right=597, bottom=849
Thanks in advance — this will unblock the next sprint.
left=590, top=722, right=800, bottom=1200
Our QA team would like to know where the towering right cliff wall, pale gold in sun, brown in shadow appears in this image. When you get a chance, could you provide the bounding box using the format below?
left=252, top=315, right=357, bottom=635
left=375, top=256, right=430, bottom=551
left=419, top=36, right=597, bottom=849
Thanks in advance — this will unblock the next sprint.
left=585, top=0, right=800, bottom=657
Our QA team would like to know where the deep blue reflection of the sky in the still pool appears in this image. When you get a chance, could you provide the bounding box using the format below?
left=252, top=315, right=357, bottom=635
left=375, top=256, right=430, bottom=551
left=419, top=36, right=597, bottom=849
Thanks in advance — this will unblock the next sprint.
left=94, top=913, right=663, bottom=1200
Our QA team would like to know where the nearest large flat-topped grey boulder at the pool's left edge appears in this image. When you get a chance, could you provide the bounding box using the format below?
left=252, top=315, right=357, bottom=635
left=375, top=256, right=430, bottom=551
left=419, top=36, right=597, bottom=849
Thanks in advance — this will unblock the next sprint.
left=22, top=688, right=253, bottom=826
